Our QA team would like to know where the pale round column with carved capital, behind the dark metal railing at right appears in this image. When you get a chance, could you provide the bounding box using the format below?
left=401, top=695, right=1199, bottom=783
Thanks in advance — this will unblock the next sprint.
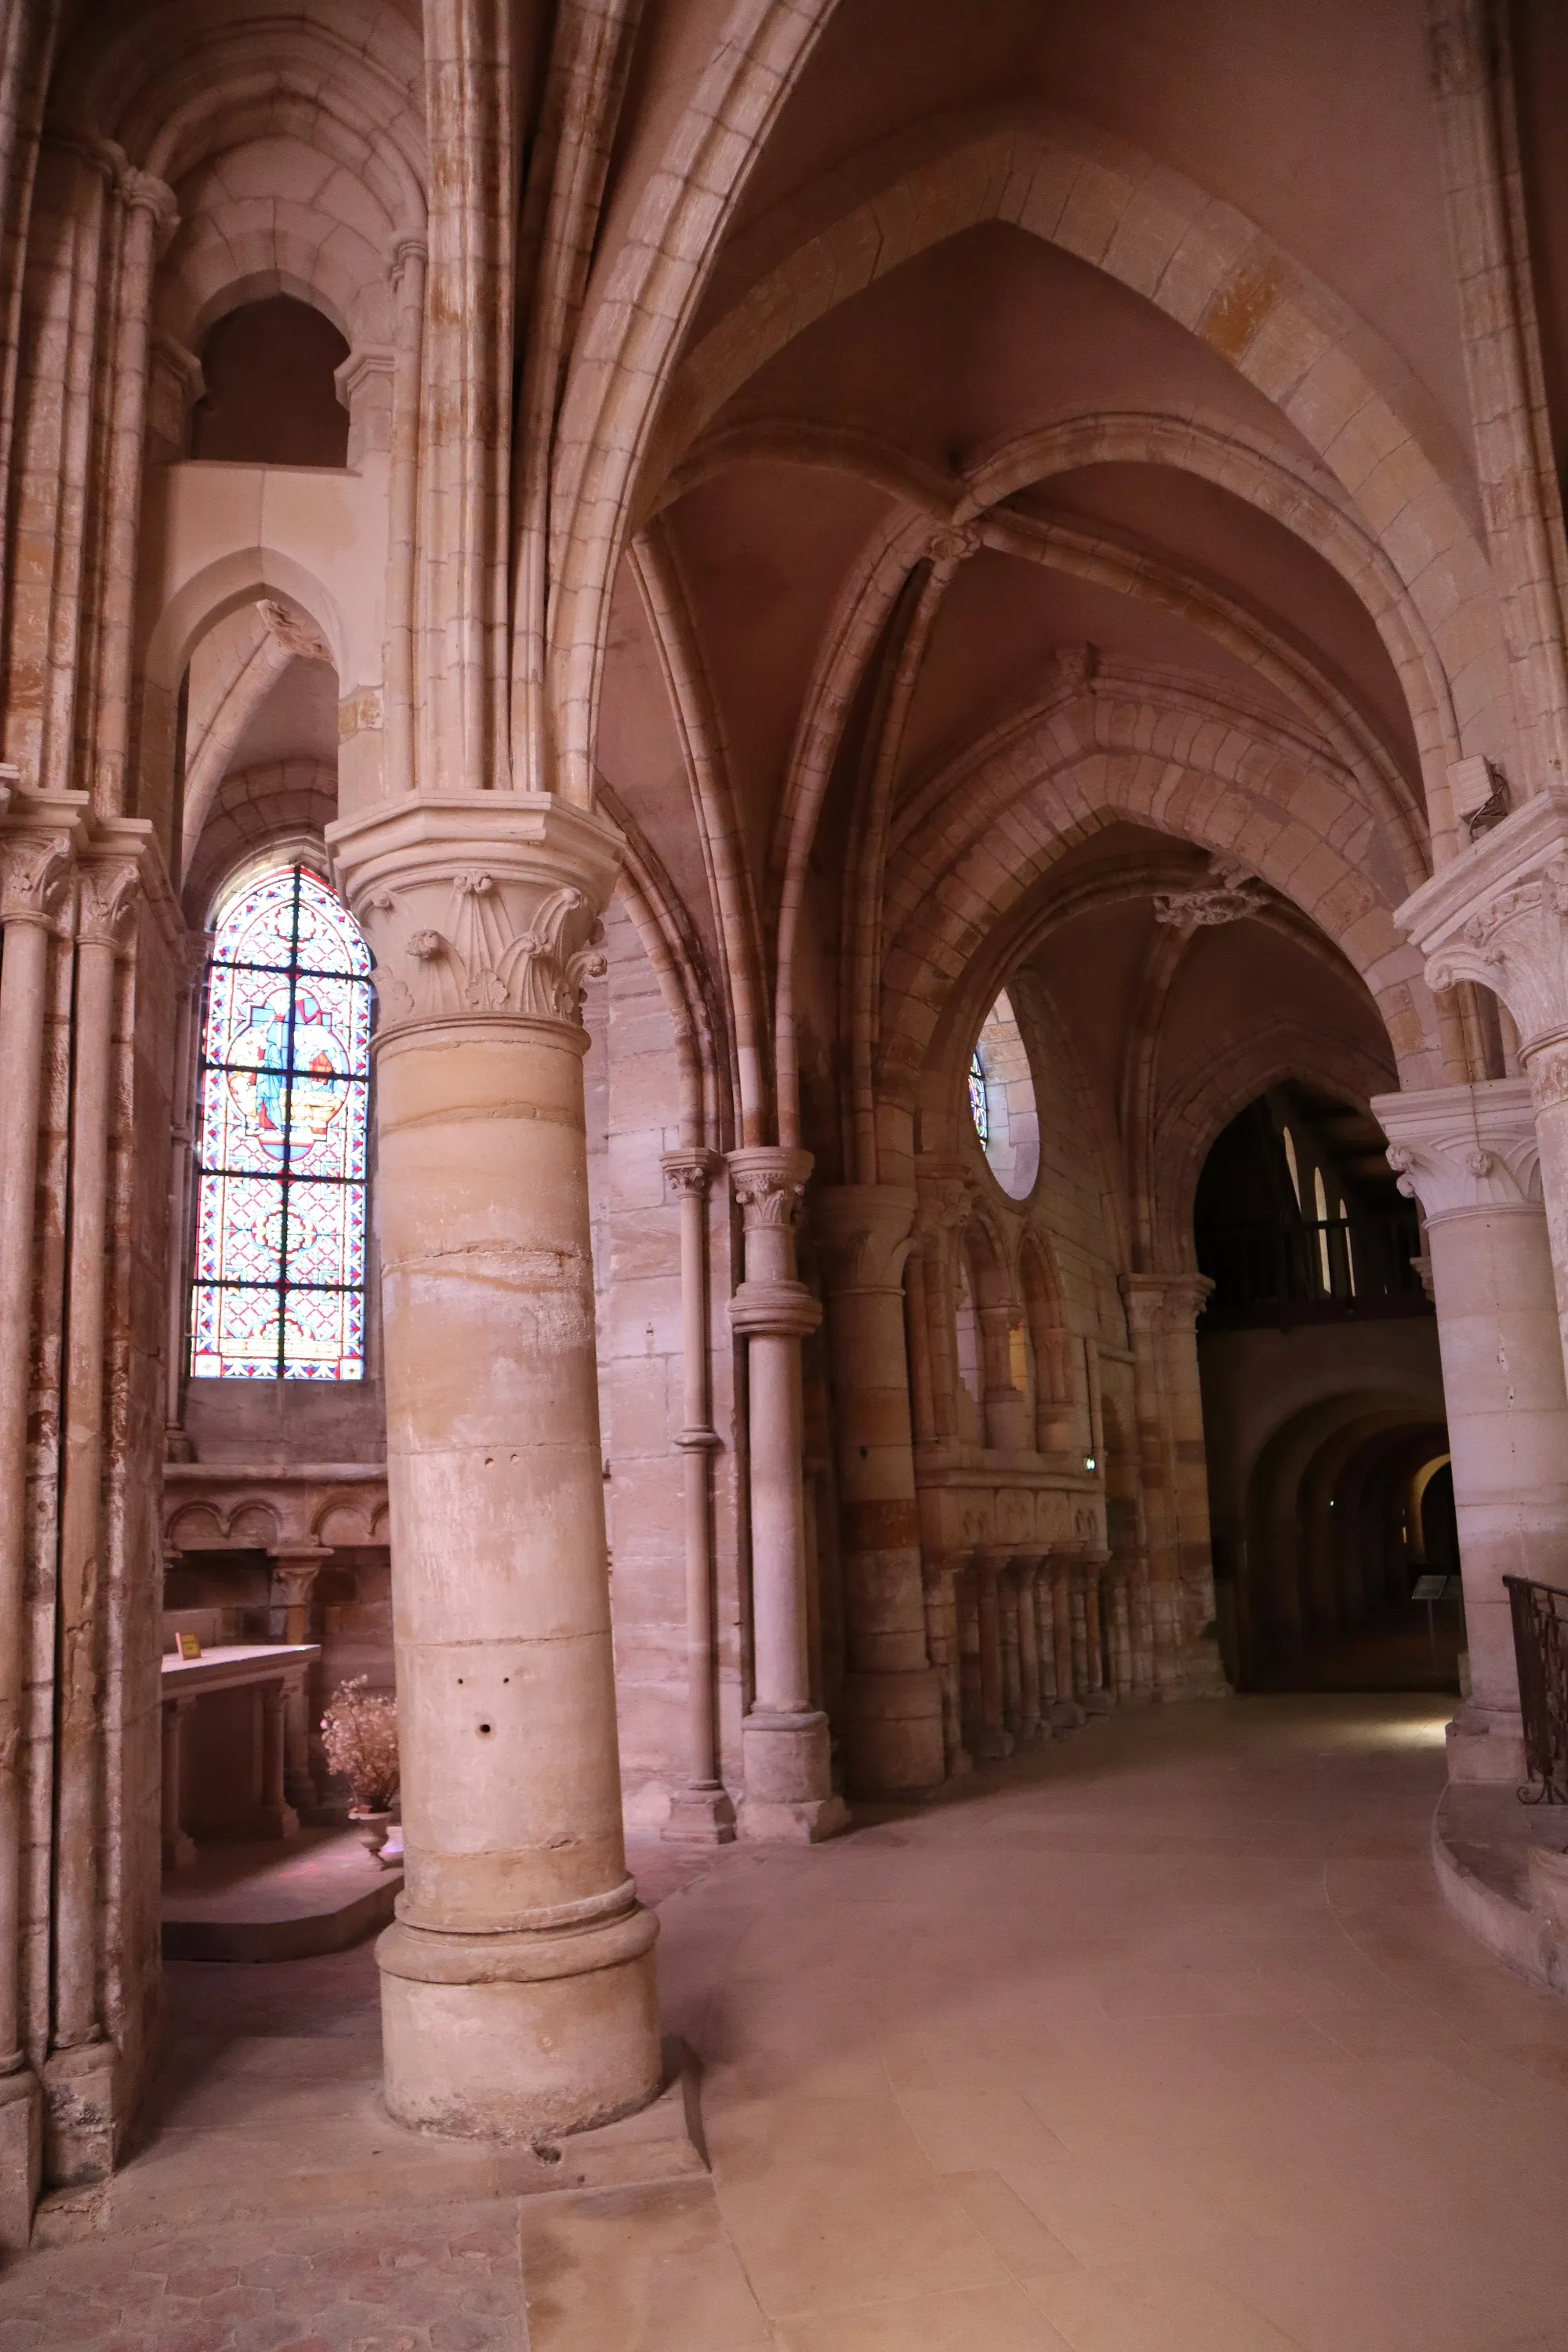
left=1373, top=1077, right=1568, bottom=1780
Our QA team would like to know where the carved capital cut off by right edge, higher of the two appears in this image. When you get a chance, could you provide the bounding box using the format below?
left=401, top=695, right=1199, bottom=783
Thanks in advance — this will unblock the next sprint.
left=1396, top=788, right=1568, bottom=1061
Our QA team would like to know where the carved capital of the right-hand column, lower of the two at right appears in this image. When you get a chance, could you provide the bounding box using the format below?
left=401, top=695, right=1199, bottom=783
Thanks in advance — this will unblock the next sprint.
left=1373, top=1077, right=1542, bottom=1225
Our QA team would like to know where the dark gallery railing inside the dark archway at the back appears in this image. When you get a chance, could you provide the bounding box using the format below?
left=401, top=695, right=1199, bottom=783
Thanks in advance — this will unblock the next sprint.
left=1196, top=1211, right=1429, bottom=1327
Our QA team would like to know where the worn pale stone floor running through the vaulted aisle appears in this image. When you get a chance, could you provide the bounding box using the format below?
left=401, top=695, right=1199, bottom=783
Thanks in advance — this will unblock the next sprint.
left=0, top=1696, right=1568, bottom=2352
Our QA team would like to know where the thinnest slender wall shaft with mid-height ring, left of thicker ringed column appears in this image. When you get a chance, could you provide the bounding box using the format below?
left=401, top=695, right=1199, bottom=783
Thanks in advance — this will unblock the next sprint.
left=663, top=1152, right=736, bottom=1846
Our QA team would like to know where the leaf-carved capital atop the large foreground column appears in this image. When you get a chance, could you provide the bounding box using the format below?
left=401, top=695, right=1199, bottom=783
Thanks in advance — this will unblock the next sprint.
left=327, top=793, right=621, bottom=1037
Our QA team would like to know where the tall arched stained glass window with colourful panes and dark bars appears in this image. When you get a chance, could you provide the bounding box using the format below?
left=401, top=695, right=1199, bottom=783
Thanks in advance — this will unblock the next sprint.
left=191, top=866, right=372, bottom=1381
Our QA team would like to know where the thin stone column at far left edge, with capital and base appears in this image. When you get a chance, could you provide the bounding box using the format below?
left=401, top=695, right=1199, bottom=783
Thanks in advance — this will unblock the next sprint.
left=0, top=814, right=71, bottom=2246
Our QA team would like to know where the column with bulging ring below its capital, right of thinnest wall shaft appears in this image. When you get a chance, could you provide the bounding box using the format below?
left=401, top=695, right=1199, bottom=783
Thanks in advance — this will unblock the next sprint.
left=729, top=1143, right=848, bottom=1844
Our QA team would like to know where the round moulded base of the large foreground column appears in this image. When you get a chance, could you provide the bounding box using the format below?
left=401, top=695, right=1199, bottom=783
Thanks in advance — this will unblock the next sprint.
left=376, top=1903, right=663, bottom=2140
